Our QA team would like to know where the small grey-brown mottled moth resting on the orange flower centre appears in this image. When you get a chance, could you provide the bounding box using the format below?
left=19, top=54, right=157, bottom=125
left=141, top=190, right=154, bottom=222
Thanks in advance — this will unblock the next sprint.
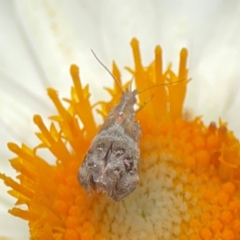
left=78, top=52, right=141, bottom=201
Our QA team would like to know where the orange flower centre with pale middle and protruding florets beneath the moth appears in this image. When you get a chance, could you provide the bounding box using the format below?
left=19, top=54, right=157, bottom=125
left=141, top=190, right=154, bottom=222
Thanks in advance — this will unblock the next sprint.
left=0, top=36, right=240, bottom=240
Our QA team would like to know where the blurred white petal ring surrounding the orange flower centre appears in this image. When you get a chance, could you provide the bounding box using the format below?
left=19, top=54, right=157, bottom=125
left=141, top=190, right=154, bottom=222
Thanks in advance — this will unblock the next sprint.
left=0, top=0, right=240, bottom=239
